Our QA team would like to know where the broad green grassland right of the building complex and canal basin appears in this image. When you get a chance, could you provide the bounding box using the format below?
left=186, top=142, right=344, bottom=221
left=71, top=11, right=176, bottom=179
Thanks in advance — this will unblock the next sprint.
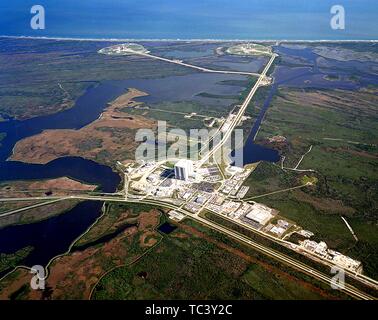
left=247, top=89, right=378, bottom=278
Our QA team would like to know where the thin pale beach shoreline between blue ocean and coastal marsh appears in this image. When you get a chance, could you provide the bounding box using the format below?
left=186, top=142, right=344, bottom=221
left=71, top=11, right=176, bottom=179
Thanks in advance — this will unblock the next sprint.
left=0, top=35, right=378, bottom=43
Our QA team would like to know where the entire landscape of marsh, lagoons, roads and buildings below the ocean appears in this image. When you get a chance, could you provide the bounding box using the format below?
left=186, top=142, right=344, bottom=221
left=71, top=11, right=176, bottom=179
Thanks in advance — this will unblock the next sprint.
left=0, top=0, right=378, bottom=306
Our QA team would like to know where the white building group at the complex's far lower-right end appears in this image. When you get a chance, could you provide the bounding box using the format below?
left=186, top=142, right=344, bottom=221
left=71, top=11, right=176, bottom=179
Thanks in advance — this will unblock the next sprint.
left=300, top=239, right=362, bottom=272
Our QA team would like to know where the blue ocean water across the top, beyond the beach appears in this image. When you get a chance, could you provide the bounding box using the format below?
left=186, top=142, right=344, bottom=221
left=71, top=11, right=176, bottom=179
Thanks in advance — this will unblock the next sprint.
left=0, top=0, right=378, bottom=40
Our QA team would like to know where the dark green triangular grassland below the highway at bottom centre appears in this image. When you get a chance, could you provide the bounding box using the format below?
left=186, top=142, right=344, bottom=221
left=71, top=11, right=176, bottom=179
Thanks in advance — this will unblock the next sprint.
left=92, top=215, right=345, bottom=299
